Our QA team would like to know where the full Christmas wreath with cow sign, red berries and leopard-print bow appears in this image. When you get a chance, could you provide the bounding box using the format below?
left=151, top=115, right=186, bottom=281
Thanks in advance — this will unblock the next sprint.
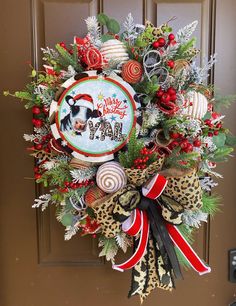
left=4, top=14, right=235, bottom=300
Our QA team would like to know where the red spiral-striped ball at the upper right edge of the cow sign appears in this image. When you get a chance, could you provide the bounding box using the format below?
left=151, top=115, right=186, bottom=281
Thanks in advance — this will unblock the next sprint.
left=121, top=60, right=143, bottom=84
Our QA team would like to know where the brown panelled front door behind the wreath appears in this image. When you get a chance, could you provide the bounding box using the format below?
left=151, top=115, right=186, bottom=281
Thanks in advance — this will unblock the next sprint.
left=0, top=0, right=236, bottom=306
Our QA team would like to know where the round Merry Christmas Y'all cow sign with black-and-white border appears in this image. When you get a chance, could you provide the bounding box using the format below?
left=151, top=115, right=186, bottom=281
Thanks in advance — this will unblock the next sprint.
left=50, top=71, right=137, bottom=162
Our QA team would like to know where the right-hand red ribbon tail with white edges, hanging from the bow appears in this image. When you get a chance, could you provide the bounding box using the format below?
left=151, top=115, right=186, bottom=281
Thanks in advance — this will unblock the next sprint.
left=166, top=223, right=211, bottom=275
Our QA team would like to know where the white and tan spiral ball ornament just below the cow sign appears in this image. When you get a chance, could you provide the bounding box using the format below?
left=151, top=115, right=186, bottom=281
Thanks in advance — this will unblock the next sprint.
left=96, top=162, right=127, bottom=193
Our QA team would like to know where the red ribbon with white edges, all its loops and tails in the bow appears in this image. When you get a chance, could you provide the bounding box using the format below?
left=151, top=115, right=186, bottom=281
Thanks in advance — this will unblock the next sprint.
left=113, top=174, right=211, bottom=275
